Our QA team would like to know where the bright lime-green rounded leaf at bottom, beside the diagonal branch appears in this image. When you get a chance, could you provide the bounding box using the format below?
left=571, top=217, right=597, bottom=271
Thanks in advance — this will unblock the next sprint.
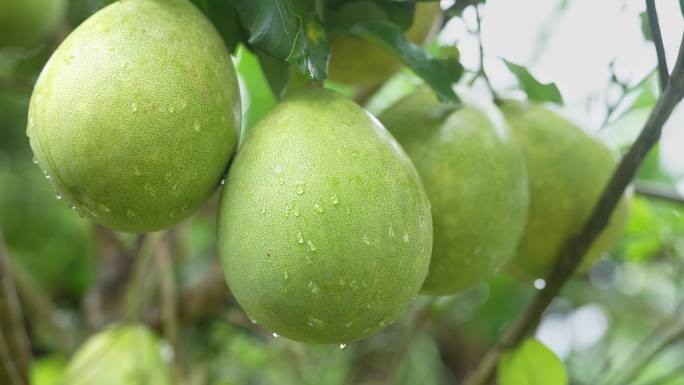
left=497, top=338, right=568, bottom=385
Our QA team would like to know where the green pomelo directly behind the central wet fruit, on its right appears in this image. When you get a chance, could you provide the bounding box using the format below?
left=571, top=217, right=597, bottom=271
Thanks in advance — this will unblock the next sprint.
left=380, top=88, right=528, bottom=295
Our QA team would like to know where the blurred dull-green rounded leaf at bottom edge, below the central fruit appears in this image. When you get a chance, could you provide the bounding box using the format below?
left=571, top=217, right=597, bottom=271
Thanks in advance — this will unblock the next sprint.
left=394, top=333, right=446, bottom=385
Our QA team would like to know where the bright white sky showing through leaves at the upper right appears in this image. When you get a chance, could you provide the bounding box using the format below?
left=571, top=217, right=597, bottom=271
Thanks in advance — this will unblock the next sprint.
left=440, top=0, right=684, bottom=188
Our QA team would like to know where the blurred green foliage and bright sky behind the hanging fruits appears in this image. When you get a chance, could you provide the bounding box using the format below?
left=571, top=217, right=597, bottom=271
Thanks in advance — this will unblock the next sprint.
left=0, top=0, right=684, bottom=385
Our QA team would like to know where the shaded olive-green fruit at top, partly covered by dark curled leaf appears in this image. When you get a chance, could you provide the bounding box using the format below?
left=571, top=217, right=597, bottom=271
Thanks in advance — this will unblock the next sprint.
left=329, top=2, right=440, bottom=87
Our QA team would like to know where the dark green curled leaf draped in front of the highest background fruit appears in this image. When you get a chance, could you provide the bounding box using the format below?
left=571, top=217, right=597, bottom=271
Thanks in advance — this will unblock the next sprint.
left=350, top=21, right=463, bottom=103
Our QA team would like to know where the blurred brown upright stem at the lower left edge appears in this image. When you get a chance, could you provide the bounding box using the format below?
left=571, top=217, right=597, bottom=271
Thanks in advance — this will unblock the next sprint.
left=0, top=232, right=31, bottom=385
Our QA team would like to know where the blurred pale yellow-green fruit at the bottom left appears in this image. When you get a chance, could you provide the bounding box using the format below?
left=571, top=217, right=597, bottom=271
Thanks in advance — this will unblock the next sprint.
left=64, top=325, right=171, bottom=385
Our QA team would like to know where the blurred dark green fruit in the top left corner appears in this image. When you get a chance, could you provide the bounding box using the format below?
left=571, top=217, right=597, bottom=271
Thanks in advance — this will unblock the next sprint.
left=0, top=0, right=67, bottom=48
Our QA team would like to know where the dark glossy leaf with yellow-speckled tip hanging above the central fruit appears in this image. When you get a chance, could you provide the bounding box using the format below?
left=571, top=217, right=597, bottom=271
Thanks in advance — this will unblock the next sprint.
left=234, top=0, right=330, bottom=80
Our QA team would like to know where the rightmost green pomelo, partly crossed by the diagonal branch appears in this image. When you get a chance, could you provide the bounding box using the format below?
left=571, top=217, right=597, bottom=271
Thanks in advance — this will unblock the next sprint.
left=500, top=101, right=629, bottom=279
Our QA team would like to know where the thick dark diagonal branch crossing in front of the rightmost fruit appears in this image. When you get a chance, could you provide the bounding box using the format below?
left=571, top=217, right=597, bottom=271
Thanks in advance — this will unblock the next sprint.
left=456, top=29, right=684, bottom=385
